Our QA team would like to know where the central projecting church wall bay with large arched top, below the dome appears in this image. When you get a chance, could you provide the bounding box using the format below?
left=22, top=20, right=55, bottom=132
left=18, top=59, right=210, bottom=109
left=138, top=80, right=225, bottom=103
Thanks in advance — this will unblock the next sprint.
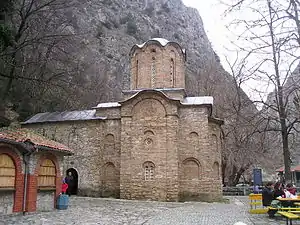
left=120, top=93, right=178, bottom=201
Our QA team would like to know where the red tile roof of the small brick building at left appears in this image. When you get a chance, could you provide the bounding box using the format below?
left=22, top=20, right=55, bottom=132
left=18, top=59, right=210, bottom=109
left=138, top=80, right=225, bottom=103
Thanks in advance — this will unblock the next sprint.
left=0, top=128, right=72, bottom=153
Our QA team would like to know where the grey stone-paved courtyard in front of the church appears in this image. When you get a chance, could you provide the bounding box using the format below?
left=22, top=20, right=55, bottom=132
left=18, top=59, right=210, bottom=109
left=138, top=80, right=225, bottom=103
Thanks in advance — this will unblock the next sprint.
left=0, top=196, right=300, bottom=225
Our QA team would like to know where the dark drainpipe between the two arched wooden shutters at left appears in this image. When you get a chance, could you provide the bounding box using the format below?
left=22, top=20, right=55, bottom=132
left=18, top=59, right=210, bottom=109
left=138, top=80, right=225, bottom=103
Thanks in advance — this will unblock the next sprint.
left=22, top=140, right=37, bottom=216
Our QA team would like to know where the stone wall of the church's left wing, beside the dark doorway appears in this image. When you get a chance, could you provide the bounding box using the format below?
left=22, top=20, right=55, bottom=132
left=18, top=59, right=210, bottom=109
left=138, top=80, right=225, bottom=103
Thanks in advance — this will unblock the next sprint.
left=26, top=119, right=120, bottom=197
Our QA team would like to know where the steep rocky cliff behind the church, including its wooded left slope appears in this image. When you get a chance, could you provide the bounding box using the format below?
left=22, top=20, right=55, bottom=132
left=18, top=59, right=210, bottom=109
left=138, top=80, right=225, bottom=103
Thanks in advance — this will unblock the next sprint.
left=0, top=0, right=257, bottom=184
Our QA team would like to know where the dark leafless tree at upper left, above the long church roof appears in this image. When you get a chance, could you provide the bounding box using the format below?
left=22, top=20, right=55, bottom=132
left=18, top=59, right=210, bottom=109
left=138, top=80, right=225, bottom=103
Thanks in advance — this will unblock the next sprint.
left=0, top=0, right=101, bottom=123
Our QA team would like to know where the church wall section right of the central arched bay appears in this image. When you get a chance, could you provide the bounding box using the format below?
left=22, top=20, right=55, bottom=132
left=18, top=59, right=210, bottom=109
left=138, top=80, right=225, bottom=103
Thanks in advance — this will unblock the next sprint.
left=179, top=106, right=222, bottom=201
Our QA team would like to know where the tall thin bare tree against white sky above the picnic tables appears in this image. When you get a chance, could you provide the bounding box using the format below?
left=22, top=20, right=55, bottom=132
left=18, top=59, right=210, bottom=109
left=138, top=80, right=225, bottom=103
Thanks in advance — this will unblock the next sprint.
left=225, top=0, right=299, bottom=182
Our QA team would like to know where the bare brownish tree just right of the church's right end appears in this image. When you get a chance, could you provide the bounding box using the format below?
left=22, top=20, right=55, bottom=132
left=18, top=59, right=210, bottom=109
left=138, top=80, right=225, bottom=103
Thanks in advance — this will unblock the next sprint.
left=221, top=55, right=266, bottom=186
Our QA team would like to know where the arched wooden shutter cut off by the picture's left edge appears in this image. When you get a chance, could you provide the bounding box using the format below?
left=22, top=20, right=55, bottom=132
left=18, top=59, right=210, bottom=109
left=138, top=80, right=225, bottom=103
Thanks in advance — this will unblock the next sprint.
left=0, top=154, right=16, bottom=188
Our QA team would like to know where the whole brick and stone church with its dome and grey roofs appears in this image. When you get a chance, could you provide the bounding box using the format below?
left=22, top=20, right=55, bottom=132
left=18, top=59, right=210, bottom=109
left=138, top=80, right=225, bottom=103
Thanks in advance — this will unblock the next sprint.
left=23, top=38, right=223, bottom=201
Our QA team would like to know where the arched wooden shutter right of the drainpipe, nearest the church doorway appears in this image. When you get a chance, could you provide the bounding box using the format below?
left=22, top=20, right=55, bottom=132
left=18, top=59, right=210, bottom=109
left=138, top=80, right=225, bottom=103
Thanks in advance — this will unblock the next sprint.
left=38, top=159, right=56, bottom=188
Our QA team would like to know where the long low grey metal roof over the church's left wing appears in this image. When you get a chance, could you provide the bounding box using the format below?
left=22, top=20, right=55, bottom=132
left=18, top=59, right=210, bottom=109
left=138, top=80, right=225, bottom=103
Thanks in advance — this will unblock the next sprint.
left=23, top=109, right=106, bottom=124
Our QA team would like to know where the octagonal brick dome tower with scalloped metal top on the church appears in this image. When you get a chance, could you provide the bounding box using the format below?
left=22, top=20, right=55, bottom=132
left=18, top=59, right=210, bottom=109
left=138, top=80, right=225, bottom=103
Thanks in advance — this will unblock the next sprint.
left=130, top=38, right=186, bottom=90
